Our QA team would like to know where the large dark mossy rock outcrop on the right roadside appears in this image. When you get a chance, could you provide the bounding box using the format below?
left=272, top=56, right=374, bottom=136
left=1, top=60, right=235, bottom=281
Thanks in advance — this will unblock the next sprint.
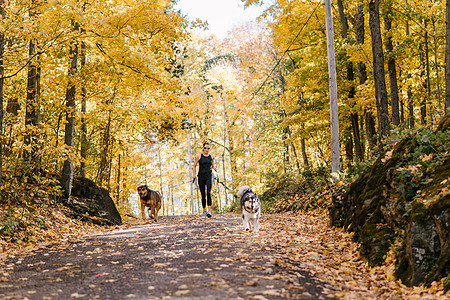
left=329, top=116, right=450, bottom=286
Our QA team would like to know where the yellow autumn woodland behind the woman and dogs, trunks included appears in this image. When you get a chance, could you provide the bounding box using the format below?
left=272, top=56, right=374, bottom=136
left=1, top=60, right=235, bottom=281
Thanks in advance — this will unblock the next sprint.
left=0, top=0, right=450, bottom=296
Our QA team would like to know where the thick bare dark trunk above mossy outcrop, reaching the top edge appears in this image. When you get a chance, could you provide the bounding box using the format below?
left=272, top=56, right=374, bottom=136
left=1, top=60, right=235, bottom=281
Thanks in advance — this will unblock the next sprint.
left=369, top=0, right=390, bottom=139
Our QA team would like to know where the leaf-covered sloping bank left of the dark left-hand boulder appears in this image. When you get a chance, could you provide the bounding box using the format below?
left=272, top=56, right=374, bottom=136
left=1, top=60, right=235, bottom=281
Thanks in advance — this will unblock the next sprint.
left=0, top=169, right=103, bottom=253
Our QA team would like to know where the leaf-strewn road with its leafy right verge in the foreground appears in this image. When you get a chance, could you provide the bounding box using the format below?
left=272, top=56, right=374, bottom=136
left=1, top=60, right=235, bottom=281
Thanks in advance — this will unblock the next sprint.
left=0, top=210, right=448, bottom=299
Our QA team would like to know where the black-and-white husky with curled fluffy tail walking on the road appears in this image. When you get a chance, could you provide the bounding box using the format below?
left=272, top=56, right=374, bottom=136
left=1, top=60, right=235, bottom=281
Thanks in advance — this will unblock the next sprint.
left=237, top=185, right=261, bottom=231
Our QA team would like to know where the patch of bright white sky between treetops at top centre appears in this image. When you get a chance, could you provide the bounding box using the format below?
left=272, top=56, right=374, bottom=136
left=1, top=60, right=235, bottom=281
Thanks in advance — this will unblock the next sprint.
left=172, top=0, right=263, bottom=39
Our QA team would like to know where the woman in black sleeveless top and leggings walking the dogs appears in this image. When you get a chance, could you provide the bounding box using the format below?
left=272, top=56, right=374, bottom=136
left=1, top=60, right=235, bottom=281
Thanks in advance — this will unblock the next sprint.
left=192, top=141, right=217, bottom=218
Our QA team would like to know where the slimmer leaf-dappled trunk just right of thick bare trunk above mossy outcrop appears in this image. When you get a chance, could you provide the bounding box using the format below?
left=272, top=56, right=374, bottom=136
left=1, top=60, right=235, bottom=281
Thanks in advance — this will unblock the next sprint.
left=384, top=5, right=400, bottom=126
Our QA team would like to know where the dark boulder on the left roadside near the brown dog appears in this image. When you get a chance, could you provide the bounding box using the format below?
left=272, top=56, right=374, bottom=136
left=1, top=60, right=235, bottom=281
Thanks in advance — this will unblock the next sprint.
left=68, top=178, right=122, bottom=225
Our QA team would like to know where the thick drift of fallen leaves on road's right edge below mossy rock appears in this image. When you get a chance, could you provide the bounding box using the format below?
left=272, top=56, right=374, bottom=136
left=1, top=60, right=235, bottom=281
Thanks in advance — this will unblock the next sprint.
left=244, top=209, right=449, bottom=299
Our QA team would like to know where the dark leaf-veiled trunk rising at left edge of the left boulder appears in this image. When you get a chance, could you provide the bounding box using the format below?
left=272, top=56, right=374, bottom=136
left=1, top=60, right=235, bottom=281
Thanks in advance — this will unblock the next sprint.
left=61, top=22, right=79, bottom=202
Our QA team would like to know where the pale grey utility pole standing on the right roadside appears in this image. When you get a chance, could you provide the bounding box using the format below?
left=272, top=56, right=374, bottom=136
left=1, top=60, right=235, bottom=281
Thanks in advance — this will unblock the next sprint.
left=325, top=0, right=340, bottom=181
